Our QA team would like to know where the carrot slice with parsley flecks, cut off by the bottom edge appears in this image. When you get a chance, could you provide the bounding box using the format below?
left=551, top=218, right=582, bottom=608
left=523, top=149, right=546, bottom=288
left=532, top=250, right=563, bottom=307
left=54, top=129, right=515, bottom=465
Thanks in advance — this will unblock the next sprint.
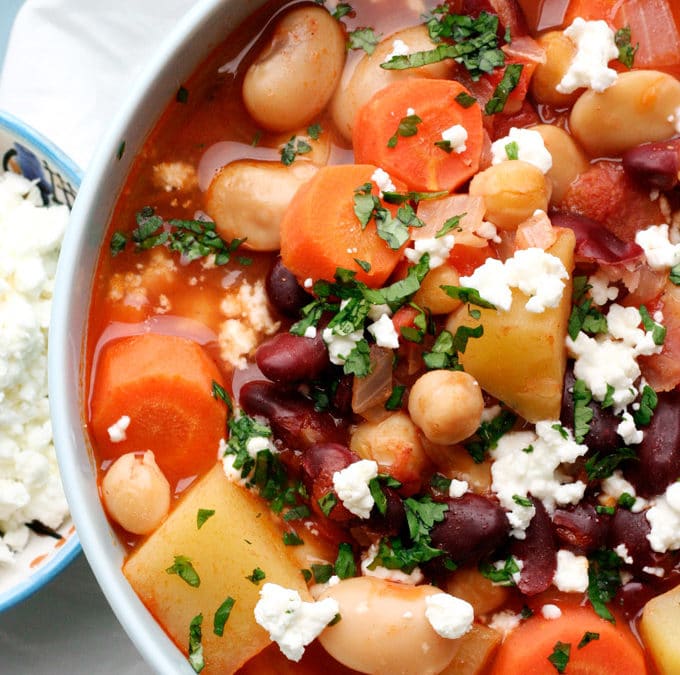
left=491, top=606, right=647, bottom=675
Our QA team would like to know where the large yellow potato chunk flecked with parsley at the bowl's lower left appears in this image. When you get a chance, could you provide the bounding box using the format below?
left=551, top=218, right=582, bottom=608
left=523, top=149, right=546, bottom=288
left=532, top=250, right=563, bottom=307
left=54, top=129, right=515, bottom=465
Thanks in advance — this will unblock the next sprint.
left=123, top=463, right=311, bottom=674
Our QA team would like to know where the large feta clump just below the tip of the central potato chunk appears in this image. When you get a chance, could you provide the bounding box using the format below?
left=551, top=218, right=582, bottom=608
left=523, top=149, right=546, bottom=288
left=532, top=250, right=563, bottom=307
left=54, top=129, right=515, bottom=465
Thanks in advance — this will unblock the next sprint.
left=491, top=421, right=588, bottom=539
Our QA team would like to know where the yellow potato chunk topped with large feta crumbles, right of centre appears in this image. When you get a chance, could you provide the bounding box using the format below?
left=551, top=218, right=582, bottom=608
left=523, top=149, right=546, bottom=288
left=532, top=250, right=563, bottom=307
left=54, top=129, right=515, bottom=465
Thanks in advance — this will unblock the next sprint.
left=447, top=228, right=575, bottom=422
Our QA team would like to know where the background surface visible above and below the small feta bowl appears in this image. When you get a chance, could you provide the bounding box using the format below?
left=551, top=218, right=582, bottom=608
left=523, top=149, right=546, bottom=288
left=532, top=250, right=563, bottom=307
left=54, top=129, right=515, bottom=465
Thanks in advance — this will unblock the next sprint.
left=0, top=0, right=195, bottom=675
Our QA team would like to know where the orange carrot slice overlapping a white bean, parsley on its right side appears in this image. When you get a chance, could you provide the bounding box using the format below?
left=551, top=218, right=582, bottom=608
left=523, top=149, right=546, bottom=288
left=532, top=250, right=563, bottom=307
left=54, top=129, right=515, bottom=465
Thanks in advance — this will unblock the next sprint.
left=281, top=164, right=405, bottom=288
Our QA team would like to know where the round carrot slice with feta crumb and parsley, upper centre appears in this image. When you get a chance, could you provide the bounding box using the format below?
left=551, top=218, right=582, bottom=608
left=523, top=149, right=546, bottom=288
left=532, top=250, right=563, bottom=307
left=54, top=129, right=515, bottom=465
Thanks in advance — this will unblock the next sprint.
left=353, top=78, right=483, bottom=192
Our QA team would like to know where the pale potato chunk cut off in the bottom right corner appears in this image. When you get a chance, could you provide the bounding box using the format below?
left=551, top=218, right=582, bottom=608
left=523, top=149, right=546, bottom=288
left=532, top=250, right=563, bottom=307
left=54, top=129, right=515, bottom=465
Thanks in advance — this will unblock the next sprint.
left=640, top=586, right=680, bottom=675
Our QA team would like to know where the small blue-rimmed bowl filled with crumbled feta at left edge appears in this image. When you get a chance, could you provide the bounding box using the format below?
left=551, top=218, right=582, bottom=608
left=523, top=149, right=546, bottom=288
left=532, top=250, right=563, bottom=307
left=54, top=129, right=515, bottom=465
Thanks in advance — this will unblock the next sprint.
left=0, top=111, right=80, bottom=612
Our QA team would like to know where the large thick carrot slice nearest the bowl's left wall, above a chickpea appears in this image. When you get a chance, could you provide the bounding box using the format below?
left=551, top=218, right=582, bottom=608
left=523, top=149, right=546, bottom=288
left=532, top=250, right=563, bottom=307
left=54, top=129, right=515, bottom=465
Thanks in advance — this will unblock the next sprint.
left=91, top=333, right=226, bottom=487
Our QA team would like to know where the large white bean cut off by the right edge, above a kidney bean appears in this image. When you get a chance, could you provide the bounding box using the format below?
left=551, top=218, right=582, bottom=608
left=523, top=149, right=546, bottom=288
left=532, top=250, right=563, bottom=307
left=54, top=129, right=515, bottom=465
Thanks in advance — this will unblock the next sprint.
left=569, top=70, right=680, bottom=157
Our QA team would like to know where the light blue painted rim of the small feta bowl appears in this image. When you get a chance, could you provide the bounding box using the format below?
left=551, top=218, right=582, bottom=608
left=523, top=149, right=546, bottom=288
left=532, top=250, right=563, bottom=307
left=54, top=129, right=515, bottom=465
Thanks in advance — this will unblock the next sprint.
left=0, top=110, right=82, bottom=613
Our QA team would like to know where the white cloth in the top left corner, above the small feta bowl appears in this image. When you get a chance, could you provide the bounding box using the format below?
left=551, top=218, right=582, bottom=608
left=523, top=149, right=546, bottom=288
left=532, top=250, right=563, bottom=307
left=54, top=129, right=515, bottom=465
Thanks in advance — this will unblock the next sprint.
left=0, top=0, right=196, bottom=170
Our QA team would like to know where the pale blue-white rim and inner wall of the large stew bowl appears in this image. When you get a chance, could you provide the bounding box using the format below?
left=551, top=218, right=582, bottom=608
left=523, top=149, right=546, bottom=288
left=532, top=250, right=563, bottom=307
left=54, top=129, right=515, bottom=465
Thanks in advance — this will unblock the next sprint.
left=49, top=0, right=264, bottom=675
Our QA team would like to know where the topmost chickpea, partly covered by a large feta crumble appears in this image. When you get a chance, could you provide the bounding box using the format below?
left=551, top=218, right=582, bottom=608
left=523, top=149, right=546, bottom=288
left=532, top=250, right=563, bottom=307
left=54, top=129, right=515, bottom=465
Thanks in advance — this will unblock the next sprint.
left=531, top=30, right=583, bottom=108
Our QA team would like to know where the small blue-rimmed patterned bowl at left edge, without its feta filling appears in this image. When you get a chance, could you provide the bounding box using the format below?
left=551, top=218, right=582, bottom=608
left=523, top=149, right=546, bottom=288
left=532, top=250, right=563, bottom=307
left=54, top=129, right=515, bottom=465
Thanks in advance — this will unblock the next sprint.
left=0, top=112, right=80, bottom=612
